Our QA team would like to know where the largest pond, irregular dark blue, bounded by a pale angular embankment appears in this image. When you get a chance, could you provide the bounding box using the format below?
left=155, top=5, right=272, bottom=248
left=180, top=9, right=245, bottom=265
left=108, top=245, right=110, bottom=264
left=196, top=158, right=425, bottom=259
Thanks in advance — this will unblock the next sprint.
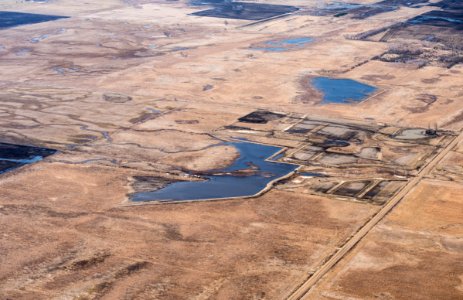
left=132, top=142, right=297, bottom=202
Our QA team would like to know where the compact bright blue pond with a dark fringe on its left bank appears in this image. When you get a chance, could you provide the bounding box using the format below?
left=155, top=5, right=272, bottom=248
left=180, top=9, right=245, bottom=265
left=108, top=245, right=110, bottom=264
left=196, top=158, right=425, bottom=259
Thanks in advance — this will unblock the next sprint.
left=312, top=77, right=377, bottom=104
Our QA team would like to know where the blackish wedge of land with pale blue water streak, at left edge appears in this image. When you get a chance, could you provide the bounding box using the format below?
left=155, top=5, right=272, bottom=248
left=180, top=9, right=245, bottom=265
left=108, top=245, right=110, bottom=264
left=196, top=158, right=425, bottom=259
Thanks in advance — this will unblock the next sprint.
left=0, top=143, right=56, bottom=174
